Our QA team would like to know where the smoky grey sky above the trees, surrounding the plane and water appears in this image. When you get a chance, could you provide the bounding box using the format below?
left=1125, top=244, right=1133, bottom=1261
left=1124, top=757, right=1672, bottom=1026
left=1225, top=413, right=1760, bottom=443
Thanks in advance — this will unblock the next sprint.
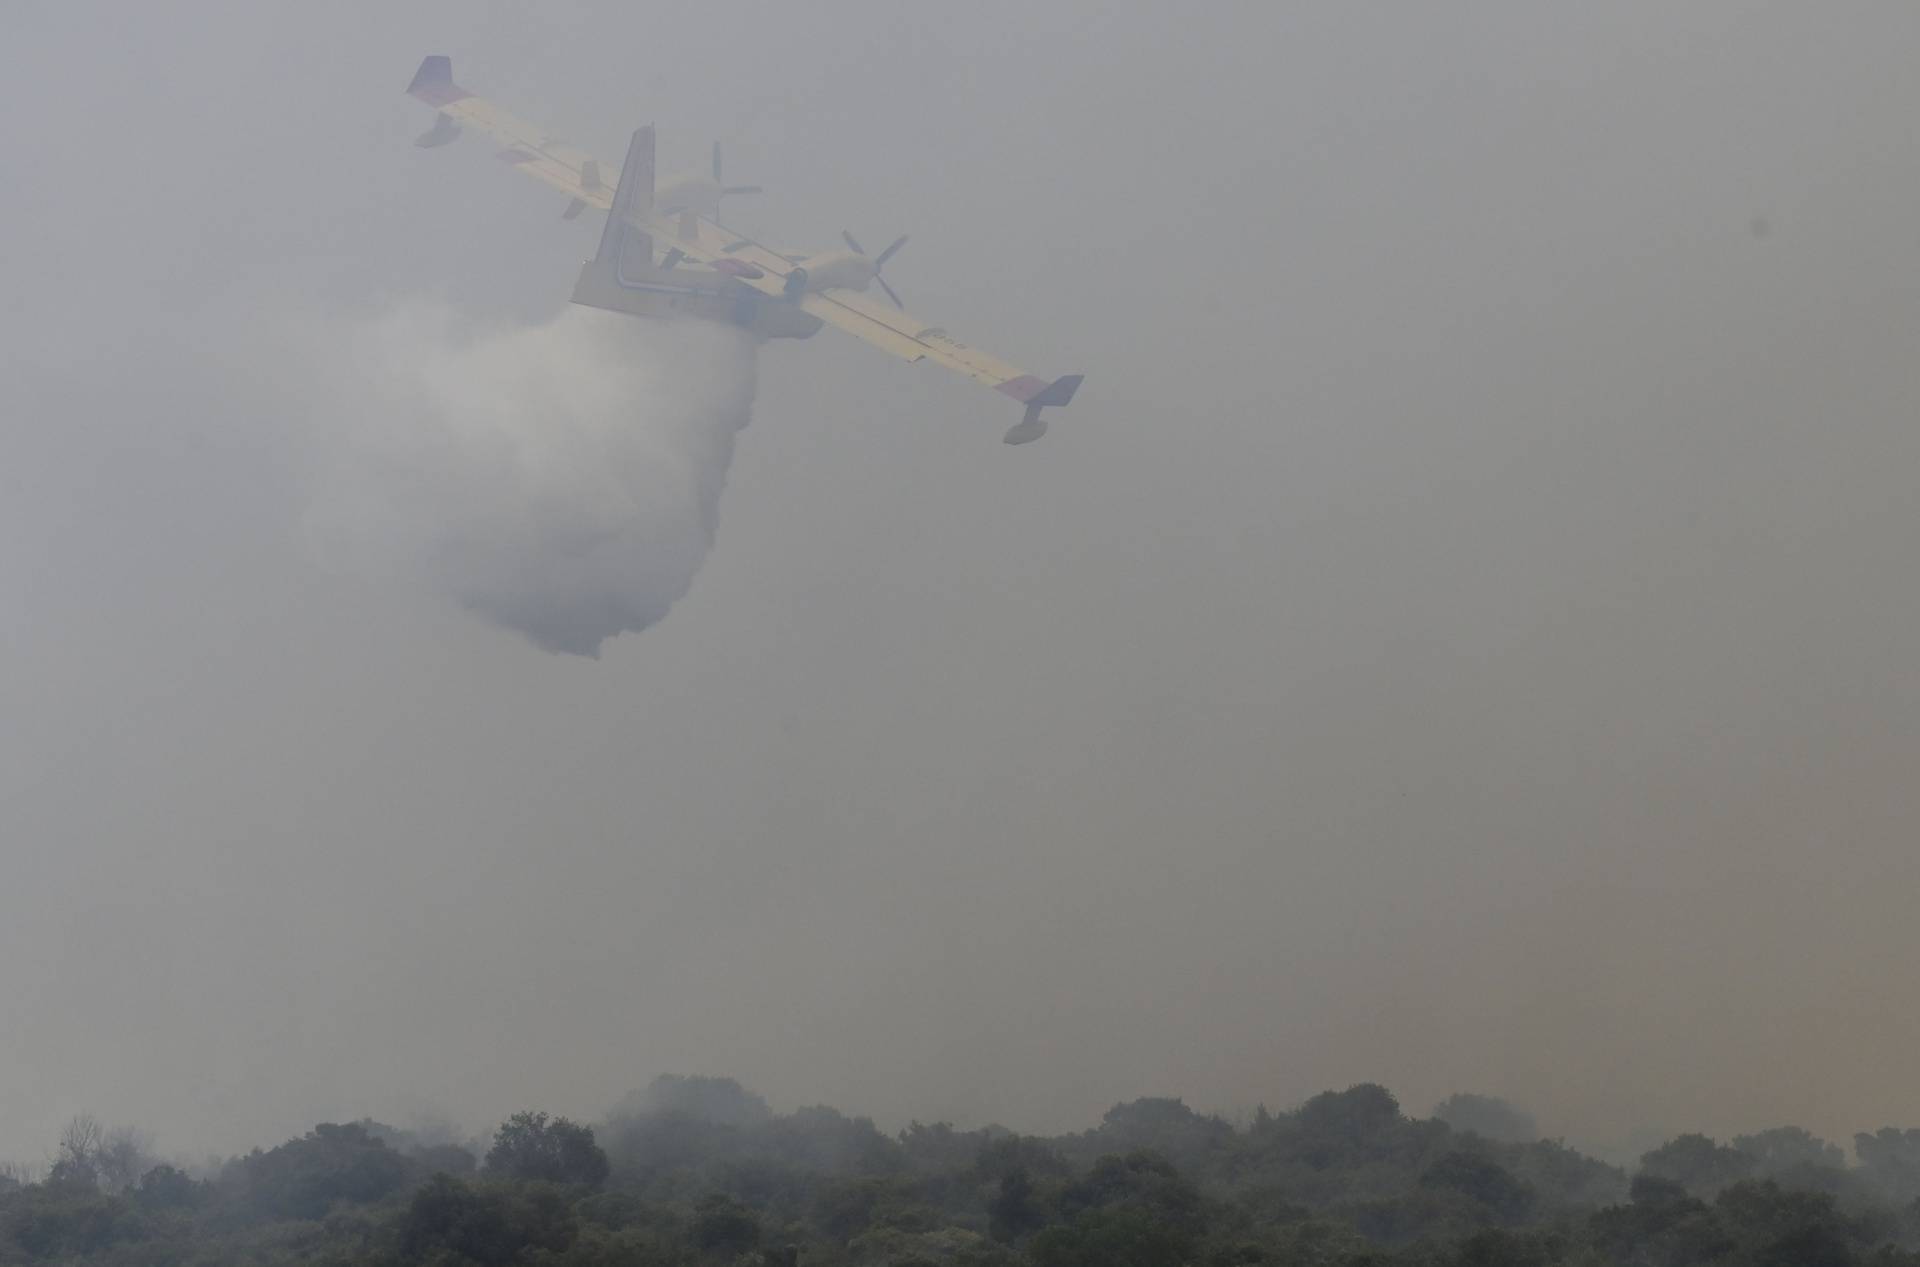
left=0, top=0, right=1920, bottom=1159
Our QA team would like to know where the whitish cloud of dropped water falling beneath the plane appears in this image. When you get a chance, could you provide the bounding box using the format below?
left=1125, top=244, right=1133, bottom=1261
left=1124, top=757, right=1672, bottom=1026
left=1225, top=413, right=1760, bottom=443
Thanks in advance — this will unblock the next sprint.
left=307, top=303, right=753, bottom=657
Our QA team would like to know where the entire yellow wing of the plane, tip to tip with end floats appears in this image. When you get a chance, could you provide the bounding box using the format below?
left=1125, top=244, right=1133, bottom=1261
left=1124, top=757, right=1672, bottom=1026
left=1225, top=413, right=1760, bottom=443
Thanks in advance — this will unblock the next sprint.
left=407, top=58, right=1081, bottom=443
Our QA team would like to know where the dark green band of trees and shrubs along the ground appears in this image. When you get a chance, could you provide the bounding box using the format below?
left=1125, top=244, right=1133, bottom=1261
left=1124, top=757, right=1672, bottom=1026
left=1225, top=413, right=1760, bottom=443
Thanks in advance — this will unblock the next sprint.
left=0, top=1077, right=1920, bottom=1267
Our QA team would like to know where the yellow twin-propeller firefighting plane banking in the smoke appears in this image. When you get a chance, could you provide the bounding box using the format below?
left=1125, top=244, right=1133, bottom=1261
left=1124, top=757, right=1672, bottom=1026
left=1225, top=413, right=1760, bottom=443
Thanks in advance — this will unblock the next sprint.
left=407, top=58, right=1081, bottom=443
